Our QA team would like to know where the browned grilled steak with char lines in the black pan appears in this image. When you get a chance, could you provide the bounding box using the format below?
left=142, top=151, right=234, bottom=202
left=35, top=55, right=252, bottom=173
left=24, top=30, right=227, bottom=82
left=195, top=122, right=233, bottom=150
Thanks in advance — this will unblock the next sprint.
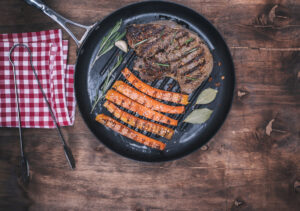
left=126, top=21, right=213, bottom=94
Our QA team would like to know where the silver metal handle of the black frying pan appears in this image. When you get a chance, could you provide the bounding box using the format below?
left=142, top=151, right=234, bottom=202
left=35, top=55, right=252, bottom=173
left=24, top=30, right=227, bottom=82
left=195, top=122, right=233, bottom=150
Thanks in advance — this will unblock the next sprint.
left=25, top=0, right=96, bottom=48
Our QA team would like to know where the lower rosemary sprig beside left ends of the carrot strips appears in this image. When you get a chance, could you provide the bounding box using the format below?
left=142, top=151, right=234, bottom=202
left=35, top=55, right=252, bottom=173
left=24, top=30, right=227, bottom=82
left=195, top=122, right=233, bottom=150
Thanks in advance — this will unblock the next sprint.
left=91, top=55, right=123, bottom=113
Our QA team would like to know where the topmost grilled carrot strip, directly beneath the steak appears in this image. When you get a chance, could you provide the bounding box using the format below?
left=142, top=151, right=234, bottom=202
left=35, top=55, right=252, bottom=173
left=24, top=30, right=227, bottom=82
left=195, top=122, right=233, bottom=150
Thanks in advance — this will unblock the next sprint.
left=122, top=68, right=189, bottom=105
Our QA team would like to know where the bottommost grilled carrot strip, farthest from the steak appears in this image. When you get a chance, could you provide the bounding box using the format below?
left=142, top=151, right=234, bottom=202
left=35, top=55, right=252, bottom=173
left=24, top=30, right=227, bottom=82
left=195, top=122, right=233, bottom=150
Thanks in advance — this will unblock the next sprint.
left=96, top=114, right=166, bottom=150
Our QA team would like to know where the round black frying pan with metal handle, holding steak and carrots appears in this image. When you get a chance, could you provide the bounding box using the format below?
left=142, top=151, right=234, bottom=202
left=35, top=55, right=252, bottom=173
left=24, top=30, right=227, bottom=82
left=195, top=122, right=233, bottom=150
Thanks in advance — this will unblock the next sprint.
left=26, top=0, right=235, bottom=162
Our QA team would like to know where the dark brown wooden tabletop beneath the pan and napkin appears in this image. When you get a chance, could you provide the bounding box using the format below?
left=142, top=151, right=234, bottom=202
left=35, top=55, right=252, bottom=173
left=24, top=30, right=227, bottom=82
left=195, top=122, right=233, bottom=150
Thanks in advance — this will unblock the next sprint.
left=0, top=0, right=300, bottom=210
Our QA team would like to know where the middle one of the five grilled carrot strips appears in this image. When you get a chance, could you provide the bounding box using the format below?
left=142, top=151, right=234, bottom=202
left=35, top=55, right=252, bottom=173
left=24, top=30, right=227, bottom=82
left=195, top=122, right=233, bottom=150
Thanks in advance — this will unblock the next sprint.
left=105, top=89, right=178, bottom=126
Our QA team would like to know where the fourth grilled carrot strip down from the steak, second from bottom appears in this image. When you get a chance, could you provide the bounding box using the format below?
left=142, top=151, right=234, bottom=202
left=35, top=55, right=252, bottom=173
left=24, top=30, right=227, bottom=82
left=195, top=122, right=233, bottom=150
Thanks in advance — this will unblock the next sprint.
left=103, top=101, right=174, bottom=139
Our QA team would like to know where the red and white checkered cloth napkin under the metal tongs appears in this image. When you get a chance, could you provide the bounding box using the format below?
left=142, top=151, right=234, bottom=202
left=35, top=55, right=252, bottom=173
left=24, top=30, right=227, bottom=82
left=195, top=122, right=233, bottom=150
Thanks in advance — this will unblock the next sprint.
left=0, top=30, right=75, bottom=128
